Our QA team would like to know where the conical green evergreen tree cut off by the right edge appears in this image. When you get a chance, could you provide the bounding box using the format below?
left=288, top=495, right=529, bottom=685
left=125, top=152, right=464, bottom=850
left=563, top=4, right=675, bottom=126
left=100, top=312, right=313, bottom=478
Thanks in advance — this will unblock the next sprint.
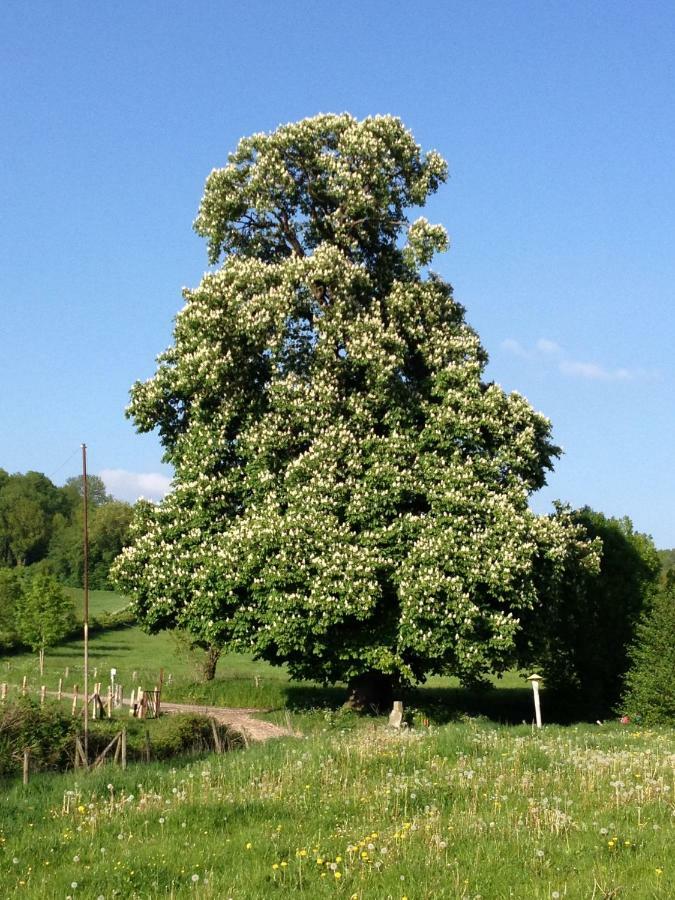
left=622, top=570, right=675, bottom=725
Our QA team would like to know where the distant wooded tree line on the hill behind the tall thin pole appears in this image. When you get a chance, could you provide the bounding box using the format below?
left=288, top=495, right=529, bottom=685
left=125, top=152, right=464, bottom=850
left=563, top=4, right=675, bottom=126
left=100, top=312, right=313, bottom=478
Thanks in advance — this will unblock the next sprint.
left=0, top=469, right=132, bottom=590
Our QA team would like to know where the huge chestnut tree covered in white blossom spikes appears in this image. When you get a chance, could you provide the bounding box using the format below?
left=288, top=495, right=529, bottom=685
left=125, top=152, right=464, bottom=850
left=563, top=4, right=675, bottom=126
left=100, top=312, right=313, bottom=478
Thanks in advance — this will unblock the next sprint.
left=116, top=115, right=600, bottom=699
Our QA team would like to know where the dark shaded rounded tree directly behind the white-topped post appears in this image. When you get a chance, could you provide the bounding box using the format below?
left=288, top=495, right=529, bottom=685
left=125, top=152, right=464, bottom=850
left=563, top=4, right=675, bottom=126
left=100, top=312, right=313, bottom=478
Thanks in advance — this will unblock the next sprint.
left=521, top=507, right=660, bottom=720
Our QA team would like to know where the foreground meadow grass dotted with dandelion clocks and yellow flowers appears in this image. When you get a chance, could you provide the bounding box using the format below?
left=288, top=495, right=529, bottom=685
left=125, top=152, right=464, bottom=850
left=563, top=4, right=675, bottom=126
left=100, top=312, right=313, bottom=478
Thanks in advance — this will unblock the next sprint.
left=0, top=717, right=675, bottom=900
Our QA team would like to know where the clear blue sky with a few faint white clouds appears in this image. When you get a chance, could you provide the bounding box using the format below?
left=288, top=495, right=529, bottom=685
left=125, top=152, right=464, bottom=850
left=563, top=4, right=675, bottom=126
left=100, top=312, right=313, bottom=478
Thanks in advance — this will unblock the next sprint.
left=0, top=0, right=675, bottom=547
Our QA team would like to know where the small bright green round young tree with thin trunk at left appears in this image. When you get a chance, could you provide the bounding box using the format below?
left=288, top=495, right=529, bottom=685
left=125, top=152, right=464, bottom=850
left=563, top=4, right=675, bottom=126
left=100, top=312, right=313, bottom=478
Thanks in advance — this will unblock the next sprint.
left=16, top=575, right=75, bottom=653
